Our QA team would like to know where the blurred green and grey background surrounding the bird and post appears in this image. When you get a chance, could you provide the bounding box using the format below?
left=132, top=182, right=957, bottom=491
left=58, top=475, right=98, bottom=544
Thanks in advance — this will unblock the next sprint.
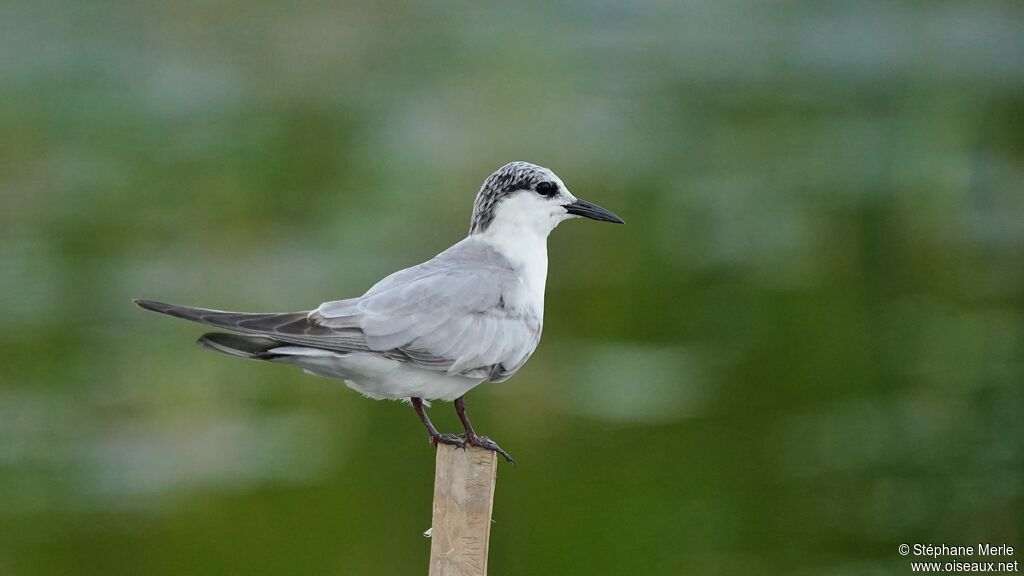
left=0, top=0, right=1024, bottom=576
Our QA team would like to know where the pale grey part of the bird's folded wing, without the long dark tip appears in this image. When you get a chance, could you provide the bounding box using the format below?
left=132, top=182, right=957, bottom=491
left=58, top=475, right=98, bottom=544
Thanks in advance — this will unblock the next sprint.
left=309, top=241, right=541, bottom=381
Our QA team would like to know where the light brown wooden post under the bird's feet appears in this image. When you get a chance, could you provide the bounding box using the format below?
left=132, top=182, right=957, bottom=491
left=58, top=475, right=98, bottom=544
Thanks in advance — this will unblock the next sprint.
left=430, top=444, right=498, bottom=576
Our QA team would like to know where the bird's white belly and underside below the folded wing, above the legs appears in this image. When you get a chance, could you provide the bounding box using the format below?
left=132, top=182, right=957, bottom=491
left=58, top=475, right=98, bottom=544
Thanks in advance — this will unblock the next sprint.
left=272, top=346, right=483, bottom=402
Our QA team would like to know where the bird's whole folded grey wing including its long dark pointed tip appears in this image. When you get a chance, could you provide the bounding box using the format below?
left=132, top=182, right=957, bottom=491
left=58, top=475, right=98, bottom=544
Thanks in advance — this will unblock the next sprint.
left=136, top=237, right=542, bottom=381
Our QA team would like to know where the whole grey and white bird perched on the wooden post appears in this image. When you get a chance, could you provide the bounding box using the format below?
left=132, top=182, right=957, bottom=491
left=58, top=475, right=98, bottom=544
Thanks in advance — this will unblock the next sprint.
left=135, top=162, right=623, bottom=462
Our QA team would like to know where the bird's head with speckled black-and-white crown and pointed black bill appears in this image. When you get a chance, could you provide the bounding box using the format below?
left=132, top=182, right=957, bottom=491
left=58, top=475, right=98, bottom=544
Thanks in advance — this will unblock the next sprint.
left=469, top=162, right=623, bottom=236
